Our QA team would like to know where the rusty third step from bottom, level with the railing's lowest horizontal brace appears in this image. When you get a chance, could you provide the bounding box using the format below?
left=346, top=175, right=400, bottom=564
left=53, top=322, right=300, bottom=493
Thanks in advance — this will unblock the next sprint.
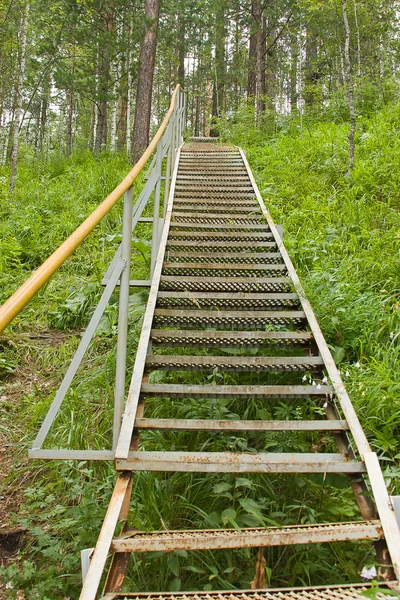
left=115, top=451, right=366, bottom=473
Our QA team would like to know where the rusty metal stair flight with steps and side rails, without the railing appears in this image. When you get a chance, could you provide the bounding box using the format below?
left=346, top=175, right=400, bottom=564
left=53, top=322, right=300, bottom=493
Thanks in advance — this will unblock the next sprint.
left=81, top=140, right=400, bottom=600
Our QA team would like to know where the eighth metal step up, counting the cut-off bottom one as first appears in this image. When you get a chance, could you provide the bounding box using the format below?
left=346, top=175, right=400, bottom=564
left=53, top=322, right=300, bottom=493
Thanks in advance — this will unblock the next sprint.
left=154, top=308, right=305, bottom=329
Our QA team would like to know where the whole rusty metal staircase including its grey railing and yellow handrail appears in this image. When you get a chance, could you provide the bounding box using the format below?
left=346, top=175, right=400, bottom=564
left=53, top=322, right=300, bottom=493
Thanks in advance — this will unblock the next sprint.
left=0, top=86, right=400, bottom=600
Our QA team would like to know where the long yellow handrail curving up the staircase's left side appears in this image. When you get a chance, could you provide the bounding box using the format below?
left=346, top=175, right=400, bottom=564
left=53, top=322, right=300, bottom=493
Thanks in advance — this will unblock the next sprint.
left=0, top=84, right=180, bottom=333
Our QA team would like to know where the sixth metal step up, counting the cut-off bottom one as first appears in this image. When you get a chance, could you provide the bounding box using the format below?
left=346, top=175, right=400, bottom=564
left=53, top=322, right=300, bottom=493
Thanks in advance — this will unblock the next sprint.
left=146, top=354, right=324, bottom=373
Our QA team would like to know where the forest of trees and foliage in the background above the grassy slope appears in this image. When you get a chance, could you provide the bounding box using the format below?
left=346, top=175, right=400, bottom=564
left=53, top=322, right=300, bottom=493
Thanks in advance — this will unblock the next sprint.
left=0, top=0, right=400, bottom=178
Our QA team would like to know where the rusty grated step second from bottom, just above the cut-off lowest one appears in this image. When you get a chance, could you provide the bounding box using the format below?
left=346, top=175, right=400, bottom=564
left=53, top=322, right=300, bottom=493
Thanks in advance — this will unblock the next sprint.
left=112, top=521, right=383, bottom=552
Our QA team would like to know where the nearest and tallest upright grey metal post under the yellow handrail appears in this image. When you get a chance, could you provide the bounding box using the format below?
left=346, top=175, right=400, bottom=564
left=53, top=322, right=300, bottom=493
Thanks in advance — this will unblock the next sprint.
left=113, top=187, right=133, bottom=449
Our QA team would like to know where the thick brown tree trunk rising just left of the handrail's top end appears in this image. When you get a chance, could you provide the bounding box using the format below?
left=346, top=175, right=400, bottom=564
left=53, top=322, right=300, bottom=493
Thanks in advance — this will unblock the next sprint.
left=132, top=0, right=160, bottom=163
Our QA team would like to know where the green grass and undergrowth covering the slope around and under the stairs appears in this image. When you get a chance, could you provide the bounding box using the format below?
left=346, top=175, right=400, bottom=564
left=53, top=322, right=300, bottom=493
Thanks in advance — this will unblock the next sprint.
left=0, top=103, right=400, bottom=600
